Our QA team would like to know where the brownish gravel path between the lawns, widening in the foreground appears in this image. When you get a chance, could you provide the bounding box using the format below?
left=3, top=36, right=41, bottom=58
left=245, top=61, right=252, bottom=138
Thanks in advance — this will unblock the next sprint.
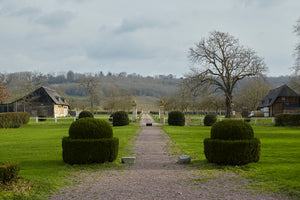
left=51, top=115, right=288, bottom=200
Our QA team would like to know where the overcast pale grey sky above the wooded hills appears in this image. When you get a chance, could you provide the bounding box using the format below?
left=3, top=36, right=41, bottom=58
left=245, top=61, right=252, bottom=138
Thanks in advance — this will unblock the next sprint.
left=0, top=0, right=300, bottom=77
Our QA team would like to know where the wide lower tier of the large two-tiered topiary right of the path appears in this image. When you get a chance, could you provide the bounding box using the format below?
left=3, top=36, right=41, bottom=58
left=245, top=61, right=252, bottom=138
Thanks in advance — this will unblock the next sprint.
left=204, top=138, right=260, bottom=165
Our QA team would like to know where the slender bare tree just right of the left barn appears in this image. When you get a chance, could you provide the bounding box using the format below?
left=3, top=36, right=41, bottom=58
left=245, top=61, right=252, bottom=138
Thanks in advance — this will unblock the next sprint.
left=80, top=76, right=100, bottom=112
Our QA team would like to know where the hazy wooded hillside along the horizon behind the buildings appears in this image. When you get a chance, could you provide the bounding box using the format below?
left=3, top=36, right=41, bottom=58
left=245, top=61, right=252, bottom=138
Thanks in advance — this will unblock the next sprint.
left=0, top=70, right=290, bottom=109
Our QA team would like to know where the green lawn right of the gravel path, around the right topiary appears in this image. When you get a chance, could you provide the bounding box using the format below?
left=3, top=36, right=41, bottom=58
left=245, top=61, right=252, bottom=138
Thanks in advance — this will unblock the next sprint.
left=163, top=126, right=300, bottom=198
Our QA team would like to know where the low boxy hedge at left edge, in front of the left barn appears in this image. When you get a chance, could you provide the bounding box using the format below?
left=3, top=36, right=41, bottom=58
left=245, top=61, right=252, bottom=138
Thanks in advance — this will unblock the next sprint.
left=0, top=112, right=30, bottom=128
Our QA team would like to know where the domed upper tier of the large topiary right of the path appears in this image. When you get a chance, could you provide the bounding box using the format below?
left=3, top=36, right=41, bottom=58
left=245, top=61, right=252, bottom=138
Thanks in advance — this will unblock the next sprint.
left=211, top=120, right=254, bottom=140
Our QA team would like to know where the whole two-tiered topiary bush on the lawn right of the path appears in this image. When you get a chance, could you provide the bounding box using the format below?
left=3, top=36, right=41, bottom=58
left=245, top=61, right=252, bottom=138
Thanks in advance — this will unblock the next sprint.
left=204, top=120, right=260, bottom=165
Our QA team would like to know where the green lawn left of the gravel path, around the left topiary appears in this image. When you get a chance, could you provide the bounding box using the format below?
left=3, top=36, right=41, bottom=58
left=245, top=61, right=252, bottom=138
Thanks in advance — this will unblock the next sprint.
left=0, top=123, right=139, bottom=199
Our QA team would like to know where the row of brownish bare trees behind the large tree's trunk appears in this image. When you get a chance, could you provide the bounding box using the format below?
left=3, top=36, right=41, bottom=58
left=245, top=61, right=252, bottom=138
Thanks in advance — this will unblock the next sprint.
left=161, top=78, right=271, bottom=114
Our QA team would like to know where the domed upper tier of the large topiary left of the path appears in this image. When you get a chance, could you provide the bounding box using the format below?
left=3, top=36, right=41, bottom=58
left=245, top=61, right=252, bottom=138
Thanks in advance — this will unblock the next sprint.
left=69, top=117, right=113, bottom=139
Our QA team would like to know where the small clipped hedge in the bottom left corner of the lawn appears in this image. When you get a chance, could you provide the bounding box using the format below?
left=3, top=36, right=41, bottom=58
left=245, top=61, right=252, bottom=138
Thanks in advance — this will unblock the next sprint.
left=0, top=162, right=20, bottom=182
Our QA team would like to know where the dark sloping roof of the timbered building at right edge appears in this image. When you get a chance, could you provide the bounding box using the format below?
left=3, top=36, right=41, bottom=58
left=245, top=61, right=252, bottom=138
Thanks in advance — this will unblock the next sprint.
left=258, top=85, right=299, bottom=109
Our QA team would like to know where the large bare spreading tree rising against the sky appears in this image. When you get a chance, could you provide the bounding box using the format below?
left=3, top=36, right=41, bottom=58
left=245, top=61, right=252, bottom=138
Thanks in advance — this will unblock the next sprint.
left=186, top=31, right=266, bottom=118
